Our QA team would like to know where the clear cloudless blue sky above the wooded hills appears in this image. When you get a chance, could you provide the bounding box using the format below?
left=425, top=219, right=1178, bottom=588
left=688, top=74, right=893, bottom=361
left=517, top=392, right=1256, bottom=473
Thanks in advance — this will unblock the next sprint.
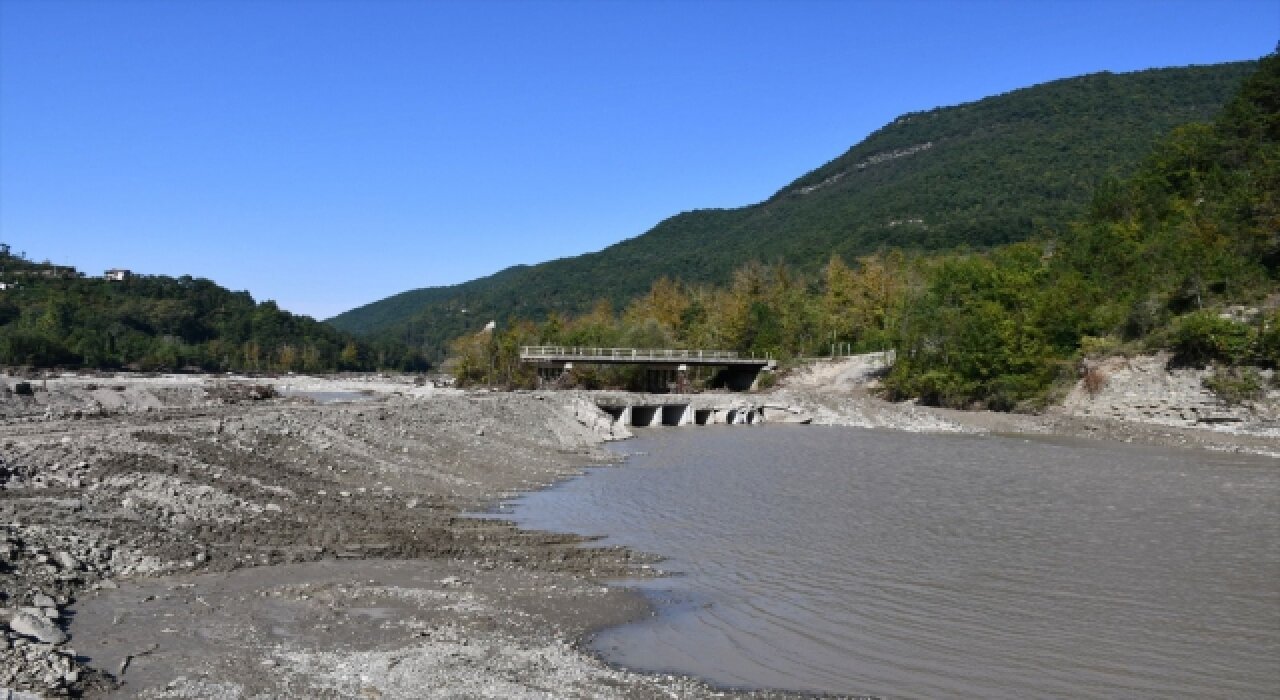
left=0, top=0, right=1280, bottom=317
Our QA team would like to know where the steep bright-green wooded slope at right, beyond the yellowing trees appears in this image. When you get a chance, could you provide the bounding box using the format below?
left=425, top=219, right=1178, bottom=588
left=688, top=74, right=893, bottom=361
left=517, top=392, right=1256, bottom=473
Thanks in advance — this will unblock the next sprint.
left=887, top=54, right=1280, bottom=408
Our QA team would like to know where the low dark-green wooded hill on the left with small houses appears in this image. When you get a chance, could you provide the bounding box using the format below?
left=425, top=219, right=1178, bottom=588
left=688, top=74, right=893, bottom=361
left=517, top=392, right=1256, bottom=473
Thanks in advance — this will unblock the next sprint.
left=0, top=250, right=426, bottom=372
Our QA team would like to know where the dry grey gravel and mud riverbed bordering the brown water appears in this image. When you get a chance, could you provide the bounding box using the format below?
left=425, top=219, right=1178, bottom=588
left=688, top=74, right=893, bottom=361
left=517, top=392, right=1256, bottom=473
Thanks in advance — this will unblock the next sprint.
left=0, top=358, right=1280, bottom=697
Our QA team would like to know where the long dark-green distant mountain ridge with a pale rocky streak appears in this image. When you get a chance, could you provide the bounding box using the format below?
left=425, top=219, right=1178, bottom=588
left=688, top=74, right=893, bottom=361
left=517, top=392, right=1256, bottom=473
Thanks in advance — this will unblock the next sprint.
left=329, top=61, right=1256, bottom=357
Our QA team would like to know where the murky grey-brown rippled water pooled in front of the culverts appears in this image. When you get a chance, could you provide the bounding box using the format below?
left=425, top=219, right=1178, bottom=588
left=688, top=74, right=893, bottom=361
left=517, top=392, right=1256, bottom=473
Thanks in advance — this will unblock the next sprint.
left=508, top=425, right=1280, bottom=699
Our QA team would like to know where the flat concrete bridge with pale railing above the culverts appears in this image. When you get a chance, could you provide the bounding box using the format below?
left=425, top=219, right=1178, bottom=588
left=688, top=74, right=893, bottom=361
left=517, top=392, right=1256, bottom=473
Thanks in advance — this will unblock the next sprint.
left=520, top=346, right=776, bottom=392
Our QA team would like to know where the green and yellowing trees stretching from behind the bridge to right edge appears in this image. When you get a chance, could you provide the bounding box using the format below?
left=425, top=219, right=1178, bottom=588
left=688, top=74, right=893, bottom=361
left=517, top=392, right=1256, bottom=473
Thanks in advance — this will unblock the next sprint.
left=452, top=54, right=1280, bottom=410
